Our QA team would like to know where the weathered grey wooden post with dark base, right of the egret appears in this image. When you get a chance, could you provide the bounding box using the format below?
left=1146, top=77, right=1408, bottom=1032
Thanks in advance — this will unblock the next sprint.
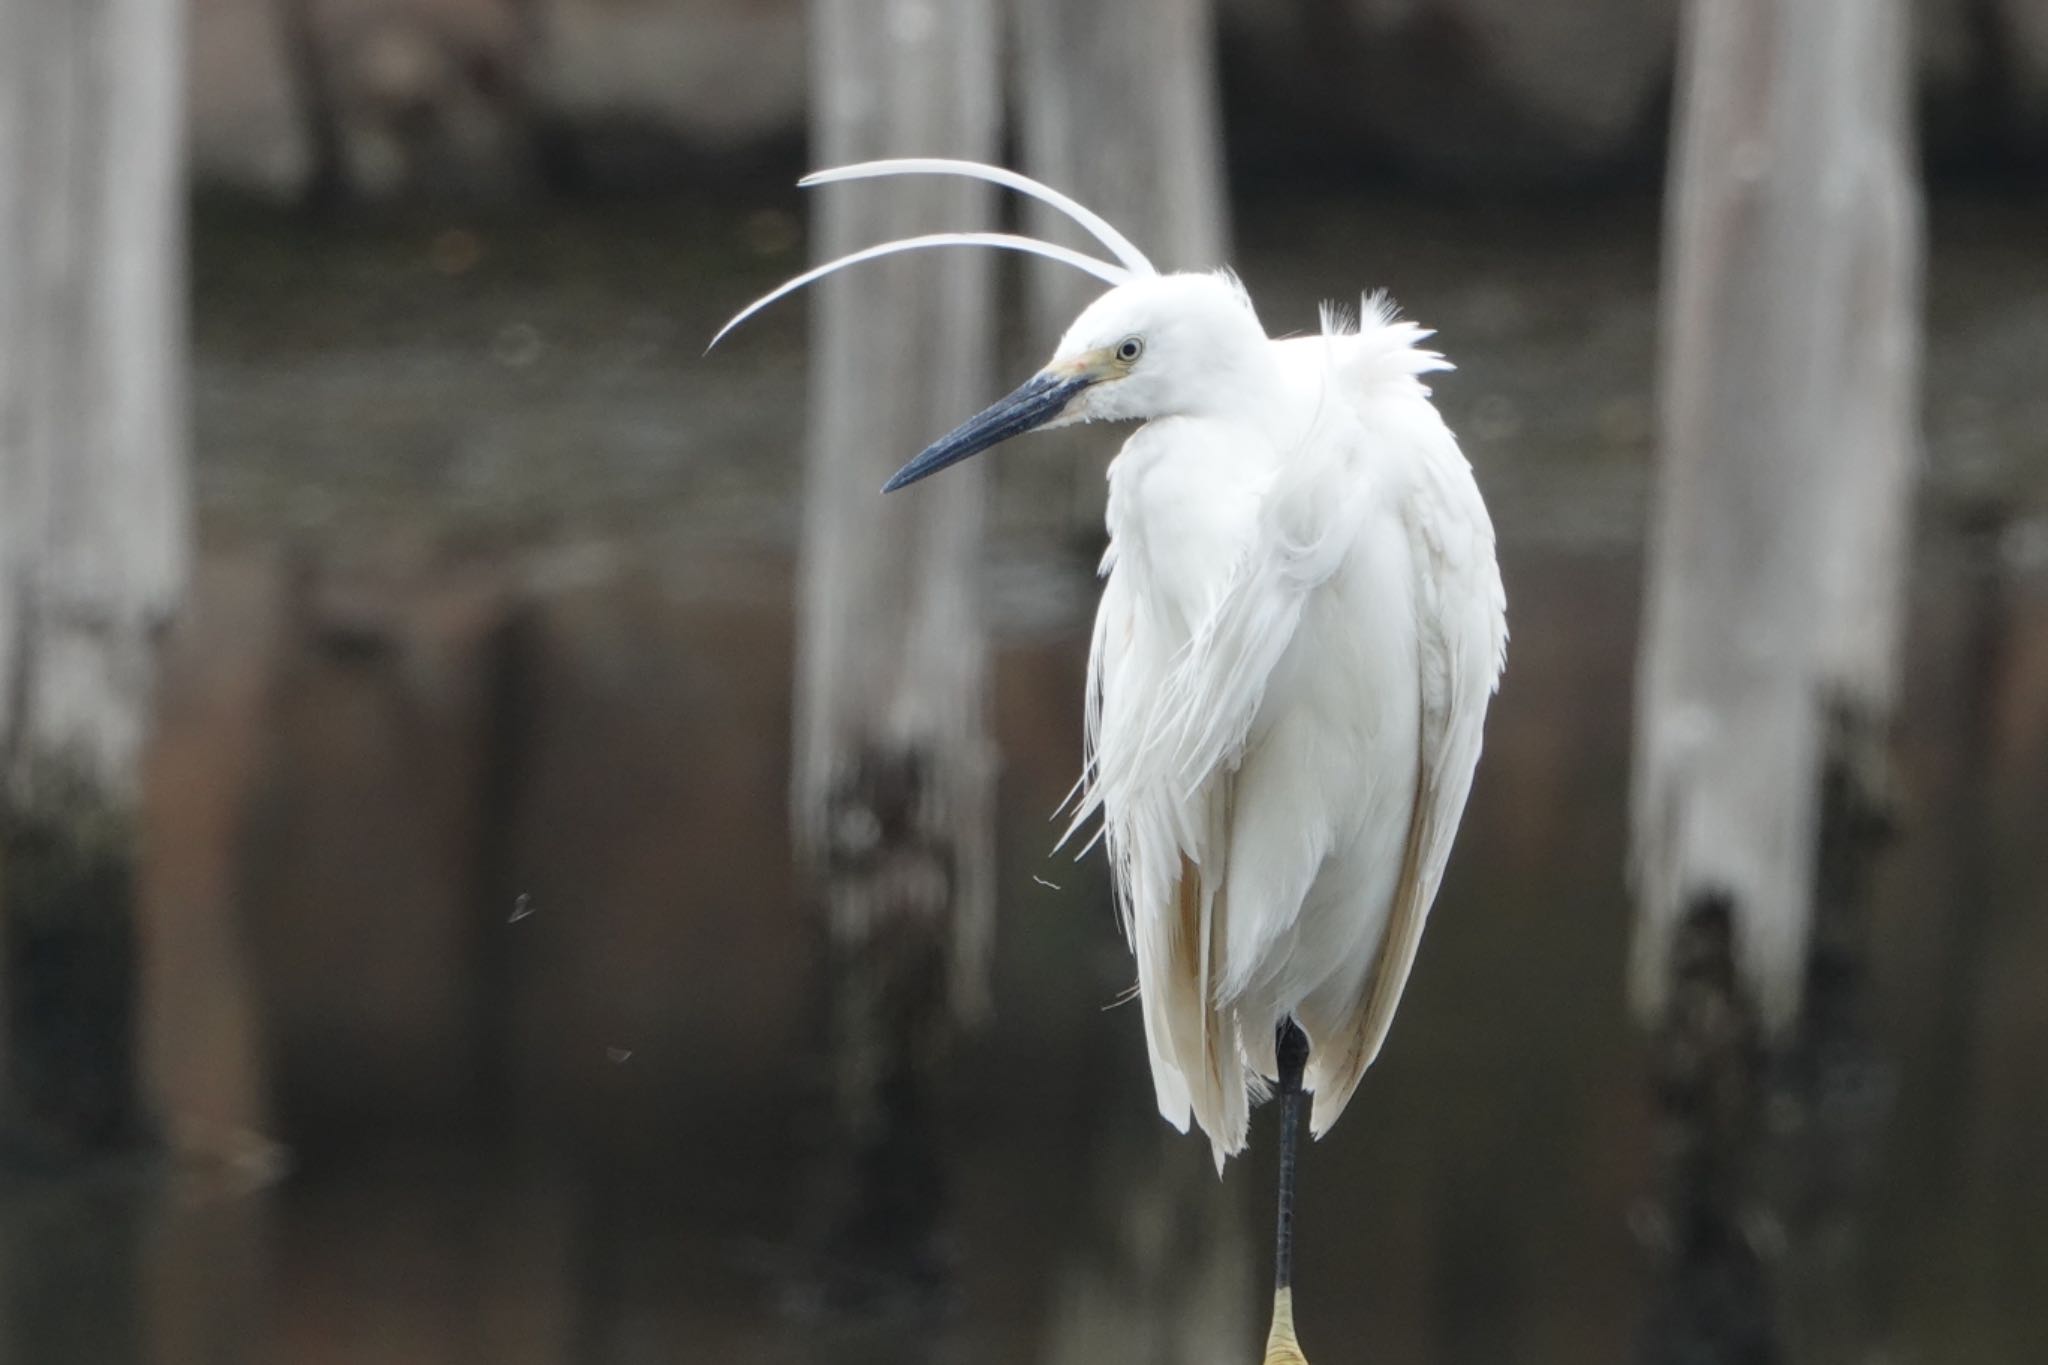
left=1632, top=0, right=1921, bottom=1361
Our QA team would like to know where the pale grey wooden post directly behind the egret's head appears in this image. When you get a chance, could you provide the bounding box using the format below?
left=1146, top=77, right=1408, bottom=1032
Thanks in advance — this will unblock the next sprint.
left=1010, top=0, right=1231, bottom=538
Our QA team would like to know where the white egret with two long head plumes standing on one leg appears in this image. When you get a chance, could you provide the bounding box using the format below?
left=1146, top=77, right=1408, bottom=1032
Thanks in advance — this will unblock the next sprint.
left=715, top=158, right=1507, bottom=1363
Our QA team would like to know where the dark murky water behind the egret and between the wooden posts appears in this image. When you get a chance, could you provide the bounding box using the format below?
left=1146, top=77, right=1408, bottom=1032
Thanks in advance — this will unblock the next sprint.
left=0, top=187, right=2048, bottom=1365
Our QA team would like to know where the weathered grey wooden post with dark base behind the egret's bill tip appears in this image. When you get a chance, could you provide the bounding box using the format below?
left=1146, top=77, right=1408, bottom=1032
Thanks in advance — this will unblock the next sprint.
left=795, top=0, right=997, bottom=1301
